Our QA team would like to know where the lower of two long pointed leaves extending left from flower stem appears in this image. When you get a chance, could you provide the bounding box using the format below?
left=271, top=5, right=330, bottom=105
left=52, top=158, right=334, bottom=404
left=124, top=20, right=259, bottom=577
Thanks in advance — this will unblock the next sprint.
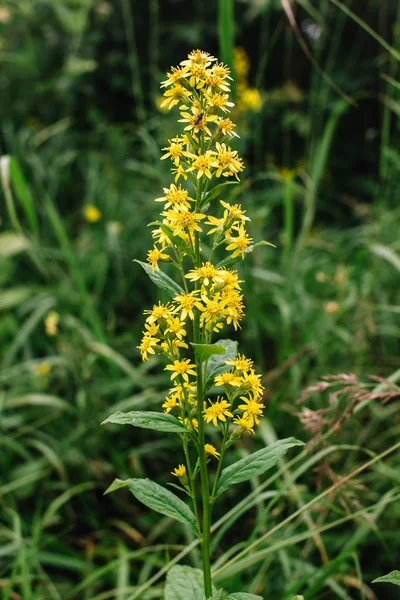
left=121, top=479, right=198, bottom=536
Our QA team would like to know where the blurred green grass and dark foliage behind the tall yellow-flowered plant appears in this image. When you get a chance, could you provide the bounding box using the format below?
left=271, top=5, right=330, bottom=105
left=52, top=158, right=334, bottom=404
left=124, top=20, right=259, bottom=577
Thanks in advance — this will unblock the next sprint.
left=0, top=0, right=400, bottom=600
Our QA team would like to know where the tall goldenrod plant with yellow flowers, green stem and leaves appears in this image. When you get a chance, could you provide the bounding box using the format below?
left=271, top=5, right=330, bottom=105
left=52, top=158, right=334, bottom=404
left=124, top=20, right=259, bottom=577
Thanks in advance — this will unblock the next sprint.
left=105, top=50, right=301, bottom=600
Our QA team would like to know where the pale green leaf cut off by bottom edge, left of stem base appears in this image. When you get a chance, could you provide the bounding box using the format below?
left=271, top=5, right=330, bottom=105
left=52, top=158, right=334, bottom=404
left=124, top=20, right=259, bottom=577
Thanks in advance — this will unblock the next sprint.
left=165, top=565, right=216, bottom=600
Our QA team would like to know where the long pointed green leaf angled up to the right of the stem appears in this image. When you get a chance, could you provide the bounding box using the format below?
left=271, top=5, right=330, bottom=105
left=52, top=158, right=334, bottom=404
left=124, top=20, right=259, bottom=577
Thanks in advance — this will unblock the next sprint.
left=215, top=437, right=303, bottom=497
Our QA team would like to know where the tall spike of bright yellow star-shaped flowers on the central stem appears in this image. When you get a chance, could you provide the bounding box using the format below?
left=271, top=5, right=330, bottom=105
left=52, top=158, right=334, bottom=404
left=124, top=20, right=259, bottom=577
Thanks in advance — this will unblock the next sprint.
left=138, top=50, right=263, bottom=464
